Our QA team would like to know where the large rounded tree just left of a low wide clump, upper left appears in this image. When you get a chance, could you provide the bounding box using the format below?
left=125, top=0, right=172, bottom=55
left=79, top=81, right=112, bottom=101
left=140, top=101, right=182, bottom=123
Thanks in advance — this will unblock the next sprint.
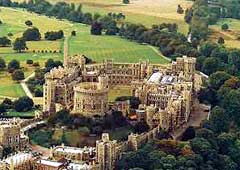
left=22, top=27, right=41, bottom=41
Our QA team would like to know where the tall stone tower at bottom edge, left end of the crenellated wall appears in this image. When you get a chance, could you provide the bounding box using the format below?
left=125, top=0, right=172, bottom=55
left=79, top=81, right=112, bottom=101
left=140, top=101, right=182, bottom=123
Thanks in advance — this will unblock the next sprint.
left=96, top=133, right=117, bottom=170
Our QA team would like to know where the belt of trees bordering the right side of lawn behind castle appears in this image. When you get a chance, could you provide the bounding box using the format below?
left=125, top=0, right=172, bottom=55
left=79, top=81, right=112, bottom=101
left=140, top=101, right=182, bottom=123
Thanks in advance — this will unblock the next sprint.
left=119, top=23, right=197, bottom=58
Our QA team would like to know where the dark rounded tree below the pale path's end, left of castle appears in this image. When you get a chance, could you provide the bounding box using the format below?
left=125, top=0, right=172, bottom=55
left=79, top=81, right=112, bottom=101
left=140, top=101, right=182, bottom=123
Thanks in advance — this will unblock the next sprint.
left=13, top=96, right=34, bottom=112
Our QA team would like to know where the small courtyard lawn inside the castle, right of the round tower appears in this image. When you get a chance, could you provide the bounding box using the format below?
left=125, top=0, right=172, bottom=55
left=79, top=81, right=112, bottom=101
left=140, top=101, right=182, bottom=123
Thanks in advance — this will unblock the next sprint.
left=108, top=86, right=131, bottom=102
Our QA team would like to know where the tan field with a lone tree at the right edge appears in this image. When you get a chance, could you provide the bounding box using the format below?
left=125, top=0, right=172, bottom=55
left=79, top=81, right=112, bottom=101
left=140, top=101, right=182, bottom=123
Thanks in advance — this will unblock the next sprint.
left=210, top=18, right=240, bottom=48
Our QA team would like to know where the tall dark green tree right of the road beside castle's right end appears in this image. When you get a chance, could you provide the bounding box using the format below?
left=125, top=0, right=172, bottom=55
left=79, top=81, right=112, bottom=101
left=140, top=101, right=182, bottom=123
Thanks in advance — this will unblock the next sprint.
left=209, top=106, right=230, bottom=133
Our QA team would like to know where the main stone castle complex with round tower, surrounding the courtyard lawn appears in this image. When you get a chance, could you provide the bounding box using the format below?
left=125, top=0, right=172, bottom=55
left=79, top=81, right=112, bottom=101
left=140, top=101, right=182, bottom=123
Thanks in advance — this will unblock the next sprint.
left=43, top=55, right=201, bottom=130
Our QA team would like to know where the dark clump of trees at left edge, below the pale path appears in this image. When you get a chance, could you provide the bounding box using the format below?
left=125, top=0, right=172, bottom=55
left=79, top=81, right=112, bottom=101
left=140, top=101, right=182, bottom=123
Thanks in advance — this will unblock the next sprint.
left=0, top=96, right=34, bottom=113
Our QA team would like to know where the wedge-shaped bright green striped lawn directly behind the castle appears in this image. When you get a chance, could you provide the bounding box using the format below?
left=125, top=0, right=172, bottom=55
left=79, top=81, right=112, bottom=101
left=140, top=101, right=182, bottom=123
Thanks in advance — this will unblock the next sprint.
left=69, top=24, right=168, bottom=63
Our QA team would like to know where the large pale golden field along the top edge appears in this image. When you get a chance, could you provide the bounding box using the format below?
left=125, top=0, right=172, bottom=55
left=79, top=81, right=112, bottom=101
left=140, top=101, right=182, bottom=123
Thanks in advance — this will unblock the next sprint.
left=49, top=0, right=192, bottom=34
